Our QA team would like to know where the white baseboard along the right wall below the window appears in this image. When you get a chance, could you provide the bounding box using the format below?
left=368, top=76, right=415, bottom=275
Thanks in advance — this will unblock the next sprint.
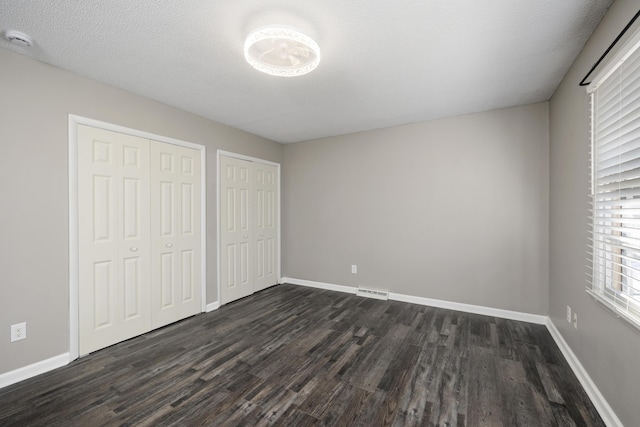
left=547, top=318, right=622, bottom=427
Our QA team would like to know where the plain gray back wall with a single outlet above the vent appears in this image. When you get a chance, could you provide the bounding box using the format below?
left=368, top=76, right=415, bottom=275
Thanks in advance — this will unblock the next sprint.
left=282, top=103, right=549, bottom=315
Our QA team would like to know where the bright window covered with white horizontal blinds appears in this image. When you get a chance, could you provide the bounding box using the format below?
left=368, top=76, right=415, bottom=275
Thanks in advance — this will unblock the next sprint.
left=588, top=25, right=640, bottom=327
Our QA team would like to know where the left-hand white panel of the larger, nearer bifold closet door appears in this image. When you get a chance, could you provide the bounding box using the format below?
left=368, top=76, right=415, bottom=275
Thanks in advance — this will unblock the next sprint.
left=78, top=125, right=151, bottom=354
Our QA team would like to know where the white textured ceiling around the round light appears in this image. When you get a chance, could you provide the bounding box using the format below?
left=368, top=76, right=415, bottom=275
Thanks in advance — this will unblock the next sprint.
left=0, top=0, right=612, bottom=143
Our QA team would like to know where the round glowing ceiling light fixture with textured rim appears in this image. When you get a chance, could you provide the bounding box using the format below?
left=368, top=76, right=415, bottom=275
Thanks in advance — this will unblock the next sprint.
left=244, top=25, right=320, bottom=77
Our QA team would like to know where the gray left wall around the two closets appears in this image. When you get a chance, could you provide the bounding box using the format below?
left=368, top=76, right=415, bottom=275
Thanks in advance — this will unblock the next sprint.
left=0, top=49, right=283, bottom=373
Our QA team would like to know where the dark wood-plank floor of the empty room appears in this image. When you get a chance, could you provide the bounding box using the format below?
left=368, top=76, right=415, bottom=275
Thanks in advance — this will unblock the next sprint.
left=0, top=285, right=604, bottom=426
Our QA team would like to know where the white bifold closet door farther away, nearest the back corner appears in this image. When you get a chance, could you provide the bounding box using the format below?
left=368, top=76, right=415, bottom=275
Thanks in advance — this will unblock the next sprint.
left=219, top=156, right=280, bottom=304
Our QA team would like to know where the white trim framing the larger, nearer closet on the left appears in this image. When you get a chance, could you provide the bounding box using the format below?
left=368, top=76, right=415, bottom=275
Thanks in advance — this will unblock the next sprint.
left=69, top=114, right=207, bottom=360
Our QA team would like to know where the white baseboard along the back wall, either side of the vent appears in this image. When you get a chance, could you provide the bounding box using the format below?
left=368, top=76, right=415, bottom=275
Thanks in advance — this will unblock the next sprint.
left=281, top=277, right=548, bottom=325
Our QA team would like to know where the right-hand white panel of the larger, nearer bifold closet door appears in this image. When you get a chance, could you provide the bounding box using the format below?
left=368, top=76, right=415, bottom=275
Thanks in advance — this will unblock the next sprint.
left=151, top=141, right=201, bottom=328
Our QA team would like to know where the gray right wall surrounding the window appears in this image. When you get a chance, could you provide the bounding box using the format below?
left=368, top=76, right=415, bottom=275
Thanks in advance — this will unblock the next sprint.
left=549, top=0, right=640, bottom=426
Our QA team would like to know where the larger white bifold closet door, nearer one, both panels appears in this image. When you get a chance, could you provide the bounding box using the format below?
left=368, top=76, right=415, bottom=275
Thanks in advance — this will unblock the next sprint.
left=78, top=125, right=201, bottom=354
